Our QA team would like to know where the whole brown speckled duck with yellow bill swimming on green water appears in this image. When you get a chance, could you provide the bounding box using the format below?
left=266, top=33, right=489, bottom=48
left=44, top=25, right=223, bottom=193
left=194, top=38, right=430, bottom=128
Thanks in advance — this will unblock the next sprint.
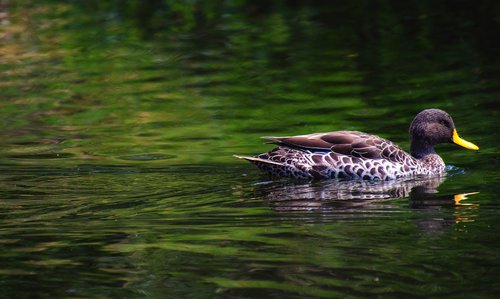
left=235, top=108, right=479, bottom=181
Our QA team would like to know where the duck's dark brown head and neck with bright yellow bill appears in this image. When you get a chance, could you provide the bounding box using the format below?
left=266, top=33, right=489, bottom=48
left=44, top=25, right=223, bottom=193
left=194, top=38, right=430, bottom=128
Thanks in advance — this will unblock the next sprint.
left=409, top=109, right=479, bottom=158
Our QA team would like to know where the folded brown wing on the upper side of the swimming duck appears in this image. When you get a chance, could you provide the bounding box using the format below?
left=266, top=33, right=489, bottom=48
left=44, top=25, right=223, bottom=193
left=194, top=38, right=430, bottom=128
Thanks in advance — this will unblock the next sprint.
left=262, top=131, right=409, bottom=162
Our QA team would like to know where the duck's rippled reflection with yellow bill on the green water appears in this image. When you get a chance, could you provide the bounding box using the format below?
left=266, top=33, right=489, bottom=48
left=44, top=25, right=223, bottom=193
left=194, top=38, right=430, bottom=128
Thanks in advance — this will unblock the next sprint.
left=255, top=177, right=477, bottom=230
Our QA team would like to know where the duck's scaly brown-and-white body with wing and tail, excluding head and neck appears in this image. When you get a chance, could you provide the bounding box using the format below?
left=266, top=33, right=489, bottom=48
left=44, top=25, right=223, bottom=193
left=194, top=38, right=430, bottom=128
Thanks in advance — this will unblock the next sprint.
left=236, top=131, right=439, bottom=180
